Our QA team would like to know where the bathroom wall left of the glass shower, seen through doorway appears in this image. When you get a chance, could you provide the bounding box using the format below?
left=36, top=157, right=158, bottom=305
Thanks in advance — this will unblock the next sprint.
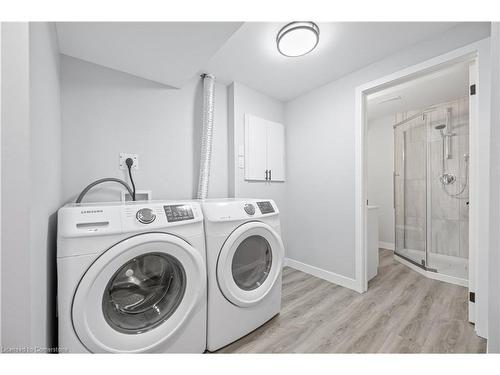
left=366, top=115, right=395, bottom=250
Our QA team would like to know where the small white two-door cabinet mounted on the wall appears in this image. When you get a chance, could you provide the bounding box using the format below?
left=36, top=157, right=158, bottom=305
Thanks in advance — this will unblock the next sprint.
left=245, top=114, right=285, bottom=182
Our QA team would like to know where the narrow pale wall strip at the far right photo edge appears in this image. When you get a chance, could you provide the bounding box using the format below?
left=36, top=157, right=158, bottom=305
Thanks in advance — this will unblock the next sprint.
left=488, top=22, right=500, bottom=353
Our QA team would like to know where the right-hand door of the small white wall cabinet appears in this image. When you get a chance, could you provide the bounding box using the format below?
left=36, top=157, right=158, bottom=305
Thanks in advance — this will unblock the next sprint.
left=267, top=121, right=285, bottom=181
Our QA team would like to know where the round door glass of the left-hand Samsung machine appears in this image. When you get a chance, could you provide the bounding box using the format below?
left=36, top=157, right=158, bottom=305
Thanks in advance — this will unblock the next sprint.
left=102, top=253, right=186, bottom=334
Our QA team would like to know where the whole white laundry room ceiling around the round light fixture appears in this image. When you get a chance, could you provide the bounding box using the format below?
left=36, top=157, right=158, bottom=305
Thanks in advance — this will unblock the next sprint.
left=57, top=22, right=488, bottom=101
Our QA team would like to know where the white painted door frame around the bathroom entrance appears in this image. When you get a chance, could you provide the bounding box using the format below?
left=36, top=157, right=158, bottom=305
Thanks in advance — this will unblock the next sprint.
left=355, top=38, right=490, bottom=337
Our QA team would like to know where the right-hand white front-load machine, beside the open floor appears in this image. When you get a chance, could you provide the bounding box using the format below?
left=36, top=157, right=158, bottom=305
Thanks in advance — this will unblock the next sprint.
left=202, top=199, right=284, bottom=351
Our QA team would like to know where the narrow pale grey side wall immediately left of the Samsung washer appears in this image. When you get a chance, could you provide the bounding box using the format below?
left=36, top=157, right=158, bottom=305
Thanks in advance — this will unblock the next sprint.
left=29, top=22, right=61, bottom=348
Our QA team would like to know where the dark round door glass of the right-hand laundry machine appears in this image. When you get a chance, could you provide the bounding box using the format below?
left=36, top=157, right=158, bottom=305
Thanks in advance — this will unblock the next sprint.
left=231, top=235, right=272, bottom=291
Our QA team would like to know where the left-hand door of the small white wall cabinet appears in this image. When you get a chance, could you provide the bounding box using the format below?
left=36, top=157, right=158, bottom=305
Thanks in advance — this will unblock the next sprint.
left=245, top=115, right=267, bottom=181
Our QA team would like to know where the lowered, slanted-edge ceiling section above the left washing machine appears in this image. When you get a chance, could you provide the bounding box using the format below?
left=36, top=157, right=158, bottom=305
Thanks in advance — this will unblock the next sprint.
left=56, top=22, right=241, bottom=87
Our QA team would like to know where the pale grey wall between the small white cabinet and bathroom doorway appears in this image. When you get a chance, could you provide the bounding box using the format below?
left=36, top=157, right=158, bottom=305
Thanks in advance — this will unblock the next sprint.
left=284, top=25, right=489, bottom=278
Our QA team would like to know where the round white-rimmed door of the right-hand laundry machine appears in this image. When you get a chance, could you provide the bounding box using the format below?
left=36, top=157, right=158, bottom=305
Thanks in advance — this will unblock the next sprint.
left=217, top=222, right=284, bottom=307
